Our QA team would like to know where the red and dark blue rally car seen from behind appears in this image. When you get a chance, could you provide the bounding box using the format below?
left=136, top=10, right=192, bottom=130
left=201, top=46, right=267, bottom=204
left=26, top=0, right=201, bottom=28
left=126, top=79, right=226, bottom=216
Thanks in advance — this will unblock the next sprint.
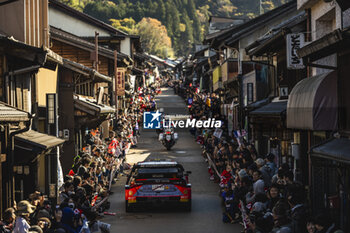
left=125, top=160, right=191, bottom=212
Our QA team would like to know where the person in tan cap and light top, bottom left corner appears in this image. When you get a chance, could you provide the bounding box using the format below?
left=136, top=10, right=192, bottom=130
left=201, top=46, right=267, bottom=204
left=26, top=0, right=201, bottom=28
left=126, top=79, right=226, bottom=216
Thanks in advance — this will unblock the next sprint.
left=13, top=201, right=35, bottom=233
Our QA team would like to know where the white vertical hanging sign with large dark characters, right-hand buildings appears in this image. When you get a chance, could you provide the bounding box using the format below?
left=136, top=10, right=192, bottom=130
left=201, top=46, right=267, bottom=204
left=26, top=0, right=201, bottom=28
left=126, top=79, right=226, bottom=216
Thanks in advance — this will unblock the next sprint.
left=286, top=33, right=305, bottom=70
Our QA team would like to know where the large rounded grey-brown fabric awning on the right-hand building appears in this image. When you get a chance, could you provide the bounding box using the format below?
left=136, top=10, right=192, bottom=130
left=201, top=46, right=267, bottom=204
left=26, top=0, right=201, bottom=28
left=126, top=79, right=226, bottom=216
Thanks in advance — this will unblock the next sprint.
left=287, top=71, right=338, bottom=130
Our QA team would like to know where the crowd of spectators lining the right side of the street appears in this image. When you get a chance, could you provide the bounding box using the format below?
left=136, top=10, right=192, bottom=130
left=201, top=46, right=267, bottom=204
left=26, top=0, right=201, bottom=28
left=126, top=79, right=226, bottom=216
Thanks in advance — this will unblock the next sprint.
left=173, top=82, right=342, bottom=233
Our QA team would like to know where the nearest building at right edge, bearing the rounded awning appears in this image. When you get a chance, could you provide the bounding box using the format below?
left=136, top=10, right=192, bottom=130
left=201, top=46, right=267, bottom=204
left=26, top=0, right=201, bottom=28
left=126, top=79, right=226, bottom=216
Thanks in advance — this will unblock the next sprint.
left=287, top=0, right=350, bottom=229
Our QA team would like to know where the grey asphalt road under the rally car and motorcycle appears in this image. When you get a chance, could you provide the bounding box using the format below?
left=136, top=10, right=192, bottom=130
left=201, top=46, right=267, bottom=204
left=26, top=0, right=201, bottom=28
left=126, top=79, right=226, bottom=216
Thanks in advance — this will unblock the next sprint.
left=101, top=89, right=242, bottom=233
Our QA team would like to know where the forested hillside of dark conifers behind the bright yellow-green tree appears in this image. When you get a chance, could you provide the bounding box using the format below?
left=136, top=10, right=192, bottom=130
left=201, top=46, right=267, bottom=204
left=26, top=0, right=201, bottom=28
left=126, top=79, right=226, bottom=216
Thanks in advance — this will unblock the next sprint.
left=61, top=0, right=289, bottom=55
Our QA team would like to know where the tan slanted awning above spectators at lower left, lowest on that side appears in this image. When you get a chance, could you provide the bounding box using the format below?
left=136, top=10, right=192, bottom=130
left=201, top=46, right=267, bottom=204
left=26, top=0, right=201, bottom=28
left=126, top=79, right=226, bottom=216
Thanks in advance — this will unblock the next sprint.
left=15, top=130, right=65, bottom=150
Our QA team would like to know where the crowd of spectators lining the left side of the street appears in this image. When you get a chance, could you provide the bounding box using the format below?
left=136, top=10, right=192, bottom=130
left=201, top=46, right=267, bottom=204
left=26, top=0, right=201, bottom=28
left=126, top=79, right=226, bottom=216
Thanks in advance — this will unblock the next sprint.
left=0, top=82, right=160, bottom=233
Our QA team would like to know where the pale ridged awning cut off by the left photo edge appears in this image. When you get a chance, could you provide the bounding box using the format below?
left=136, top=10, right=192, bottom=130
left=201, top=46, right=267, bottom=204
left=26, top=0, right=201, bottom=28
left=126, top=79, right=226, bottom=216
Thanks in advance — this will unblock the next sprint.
left=0, top=102, right=29, bottom=122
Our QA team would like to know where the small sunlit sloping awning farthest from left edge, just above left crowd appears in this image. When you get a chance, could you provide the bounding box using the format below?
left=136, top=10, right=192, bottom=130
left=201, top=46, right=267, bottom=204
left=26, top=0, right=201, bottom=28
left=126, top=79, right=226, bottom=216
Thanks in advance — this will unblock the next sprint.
left=74, top=95, right=115, bottom=116
